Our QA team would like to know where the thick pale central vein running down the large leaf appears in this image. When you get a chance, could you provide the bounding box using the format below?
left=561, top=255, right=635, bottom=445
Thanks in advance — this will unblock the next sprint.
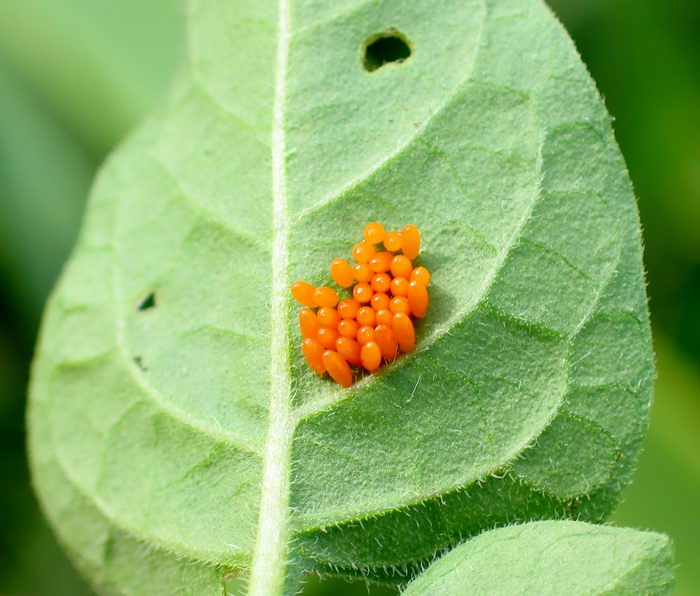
left=248, top=0, right=293, bottom=596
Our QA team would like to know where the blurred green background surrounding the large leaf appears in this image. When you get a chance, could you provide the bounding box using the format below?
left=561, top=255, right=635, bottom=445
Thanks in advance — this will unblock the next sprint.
left=0, top=0, right=700, bottom=596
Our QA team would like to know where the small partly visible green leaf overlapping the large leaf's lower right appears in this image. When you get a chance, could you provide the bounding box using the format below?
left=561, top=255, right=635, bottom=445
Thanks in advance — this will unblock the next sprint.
left=402, top=521, right=673, bottom=596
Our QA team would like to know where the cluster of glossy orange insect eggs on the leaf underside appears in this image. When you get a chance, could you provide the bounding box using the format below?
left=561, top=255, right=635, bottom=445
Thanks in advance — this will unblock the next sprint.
left=292, top=222, right=430, bottom=387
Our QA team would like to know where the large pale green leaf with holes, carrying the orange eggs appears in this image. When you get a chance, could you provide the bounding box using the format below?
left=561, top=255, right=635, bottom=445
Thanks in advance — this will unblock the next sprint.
left=30, top=0, right=653, bottom=596
